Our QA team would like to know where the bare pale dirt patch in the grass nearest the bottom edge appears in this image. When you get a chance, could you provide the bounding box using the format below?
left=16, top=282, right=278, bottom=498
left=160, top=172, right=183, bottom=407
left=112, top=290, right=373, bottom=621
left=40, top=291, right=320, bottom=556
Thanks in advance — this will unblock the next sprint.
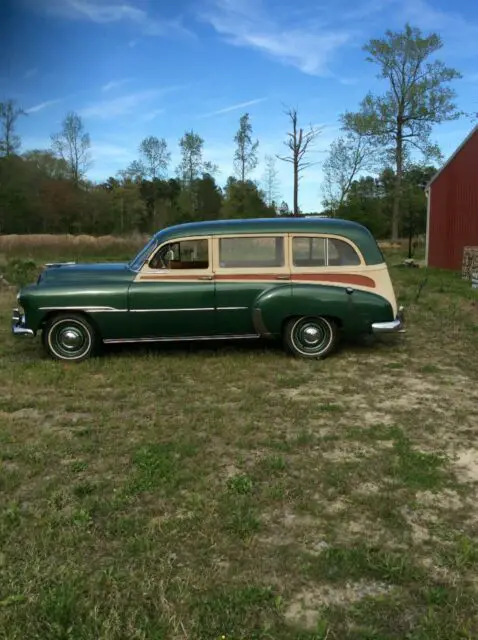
left=284, top=581, right=394, bottom=630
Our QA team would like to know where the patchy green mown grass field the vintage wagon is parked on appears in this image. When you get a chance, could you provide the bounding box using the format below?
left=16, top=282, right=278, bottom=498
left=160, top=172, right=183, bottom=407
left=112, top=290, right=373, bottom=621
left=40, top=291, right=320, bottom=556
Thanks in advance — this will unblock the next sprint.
left=0, top=246, right=478, bottom=640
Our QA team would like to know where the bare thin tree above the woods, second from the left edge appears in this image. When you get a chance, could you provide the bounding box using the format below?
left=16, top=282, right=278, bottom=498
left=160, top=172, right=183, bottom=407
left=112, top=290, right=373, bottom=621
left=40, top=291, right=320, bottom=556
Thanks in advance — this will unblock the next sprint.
left=51, top=111, right=91, bottom=184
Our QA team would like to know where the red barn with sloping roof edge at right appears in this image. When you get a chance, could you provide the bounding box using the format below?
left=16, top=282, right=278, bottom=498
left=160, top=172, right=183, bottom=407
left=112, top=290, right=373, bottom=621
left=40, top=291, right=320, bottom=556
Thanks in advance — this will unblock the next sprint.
left=426, top=126, right=478, bottom=270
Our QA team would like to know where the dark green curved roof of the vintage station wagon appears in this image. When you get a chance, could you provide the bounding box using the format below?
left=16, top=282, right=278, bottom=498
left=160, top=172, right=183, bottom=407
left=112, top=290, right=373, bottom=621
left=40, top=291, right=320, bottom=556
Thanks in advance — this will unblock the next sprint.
left=156, top=216, right=383, bottom=264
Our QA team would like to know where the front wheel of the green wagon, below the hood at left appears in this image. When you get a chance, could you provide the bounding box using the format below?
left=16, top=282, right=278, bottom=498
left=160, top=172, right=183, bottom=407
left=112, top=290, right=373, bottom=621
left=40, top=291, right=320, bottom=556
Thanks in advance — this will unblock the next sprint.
left=42, top=313, right=97, bottom=362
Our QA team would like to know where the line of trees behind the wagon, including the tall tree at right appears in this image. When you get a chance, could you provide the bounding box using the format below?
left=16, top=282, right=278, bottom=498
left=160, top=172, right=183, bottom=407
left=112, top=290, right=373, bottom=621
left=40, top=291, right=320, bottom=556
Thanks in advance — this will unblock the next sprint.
left=0, top=24, right=463, bottom=240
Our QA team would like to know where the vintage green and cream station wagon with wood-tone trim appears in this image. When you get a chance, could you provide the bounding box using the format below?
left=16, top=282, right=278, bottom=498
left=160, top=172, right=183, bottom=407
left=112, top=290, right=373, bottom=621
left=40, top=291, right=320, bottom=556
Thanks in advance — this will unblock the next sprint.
left=12, top=217, right=403, bottom=361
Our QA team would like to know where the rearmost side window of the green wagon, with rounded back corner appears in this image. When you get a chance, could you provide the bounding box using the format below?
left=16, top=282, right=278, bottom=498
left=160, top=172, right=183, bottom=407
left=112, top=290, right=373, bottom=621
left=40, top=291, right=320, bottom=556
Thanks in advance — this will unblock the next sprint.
left=292, top=237, right=360, bottom=267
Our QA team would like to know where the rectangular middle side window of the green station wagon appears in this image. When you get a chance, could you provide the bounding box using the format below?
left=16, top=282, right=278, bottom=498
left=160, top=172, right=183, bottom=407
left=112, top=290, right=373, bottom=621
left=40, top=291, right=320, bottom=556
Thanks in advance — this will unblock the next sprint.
left=219, top=236, right=285, bottom=268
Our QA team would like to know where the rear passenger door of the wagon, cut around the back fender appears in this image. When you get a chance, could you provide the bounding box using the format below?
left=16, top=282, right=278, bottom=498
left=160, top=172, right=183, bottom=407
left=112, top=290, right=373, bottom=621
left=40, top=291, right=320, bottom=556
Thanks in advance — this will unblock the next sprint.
left=214, top=234, right=291, bottom=335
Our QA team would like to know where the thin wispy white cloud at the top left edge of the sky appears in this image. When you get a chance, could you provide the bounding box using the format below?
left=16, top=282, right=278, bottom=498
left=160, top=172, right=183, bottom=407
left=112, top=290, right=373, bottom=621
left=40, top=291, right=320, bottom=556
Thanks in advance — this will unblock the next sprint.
left=38, top=0, right=191, bottom=36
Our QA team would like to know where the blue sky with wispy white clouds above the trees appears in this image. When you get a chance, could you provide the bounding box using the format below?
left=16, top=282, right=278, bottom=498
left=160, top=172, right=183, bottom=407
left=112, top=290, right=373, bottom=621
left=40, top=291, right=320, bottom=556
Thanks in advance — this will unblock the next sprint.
left=0, top=0, right=478, bottom=211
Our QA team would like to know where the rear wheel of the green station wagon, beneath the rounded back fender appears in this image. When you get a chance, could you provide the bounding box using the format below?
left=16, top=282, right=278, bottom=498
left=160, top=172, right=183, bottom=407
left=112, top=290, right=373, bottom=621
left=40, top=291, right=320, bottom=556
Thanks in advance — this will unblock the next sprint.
left=284, top=317, right=338, bottom=359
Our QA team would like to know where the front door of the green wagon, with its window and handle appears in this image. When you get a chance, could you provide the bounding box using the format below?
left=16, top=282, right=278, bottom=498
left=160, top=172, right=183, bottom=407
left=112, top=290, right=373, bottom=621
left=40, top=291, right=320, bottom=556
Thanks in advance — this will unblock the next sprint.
left=128, top=237, right=215, bottom=338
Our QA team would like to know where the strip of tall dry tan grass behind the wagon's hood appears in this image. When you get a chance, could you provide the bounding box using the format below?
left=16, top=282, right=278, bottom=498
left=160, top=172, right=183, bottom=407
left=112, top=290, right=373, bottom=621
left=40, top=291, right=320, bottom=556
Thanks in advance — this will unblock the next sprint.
left=0, top=233, right=148, bottom=260
